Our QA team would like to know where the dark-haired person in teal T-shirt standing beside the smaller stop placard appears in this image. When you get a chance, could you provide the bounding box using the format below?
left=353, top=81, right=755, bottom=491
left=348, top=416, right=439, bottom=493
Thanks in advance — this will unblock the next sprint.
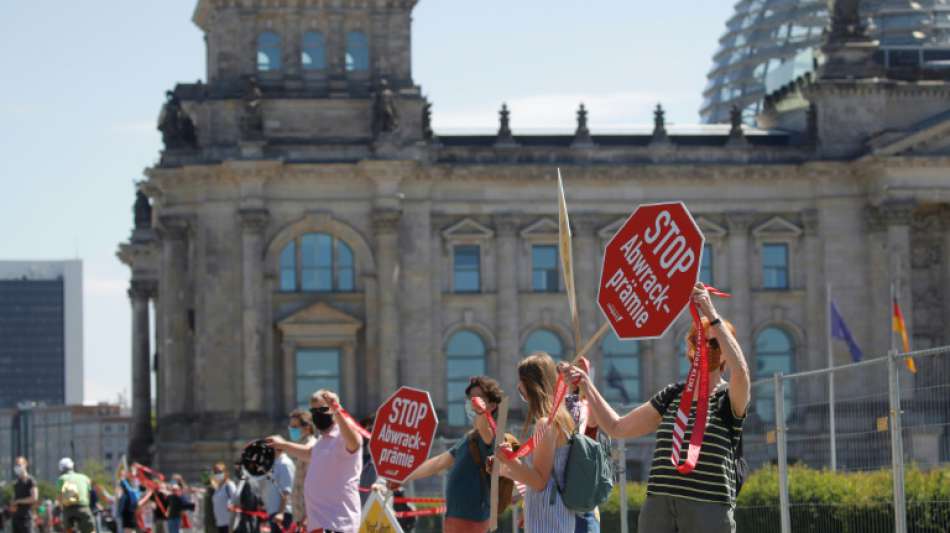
left=406, top=376, right=504, bottom=533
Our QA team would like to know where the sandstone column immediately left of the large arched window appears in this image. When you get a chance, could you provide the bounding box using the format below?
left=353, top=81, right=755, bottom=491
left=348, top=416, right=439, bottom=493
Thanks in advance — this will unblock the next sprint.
left=238, top=209, right=270, bottom=413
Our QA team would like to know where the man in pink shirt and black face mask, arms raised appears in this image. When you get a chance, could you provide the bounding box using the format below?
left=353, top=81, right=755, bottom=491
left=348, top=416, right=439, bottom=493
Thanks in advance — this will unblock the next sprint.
left=267, top=390, right=363, bottom=533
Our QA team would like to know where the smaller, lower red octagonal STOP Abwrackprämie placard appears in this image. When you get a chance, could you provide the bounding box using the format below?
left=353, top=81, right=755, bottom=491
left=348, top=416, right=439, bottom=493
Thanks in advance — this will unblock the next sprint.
left=369, top=387, right=439, bottom=483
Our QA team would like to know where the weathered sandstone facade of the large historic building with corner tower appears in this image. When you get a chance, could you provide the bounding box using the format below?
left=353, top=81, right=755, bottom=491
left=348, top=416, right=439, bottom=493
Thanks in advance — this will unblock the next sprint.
left=120, top=0, right=950, bottom=472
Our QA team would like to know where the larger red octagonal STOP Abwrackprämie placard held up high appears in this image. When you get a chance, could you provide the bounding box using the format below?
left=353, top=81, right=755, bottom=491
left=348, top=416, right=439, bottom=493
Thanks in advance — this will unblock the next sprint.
left=597, top=202, right=703, bottom=339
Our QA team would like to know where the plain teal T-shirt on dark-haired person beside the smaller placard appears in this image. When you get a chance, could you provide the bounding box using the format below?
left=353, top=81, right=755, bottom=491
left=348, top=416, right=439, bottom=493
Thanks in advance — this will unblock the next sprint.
left=445, top=433, right=492, bottom=522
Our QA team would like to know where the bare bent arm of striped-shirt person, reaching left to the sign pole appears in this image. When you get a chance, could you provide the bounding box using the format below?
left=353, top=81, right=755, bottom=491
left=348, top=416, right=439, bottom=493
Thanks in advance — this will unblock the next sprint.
left=561, top=365, right=662, bottom=439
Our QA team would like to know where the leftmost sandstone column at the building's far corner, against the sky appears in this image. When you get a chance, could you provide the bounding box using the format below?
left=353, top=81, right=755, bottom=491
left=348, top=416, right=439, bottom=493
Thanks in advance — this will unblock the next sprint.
left=129, top=280, right=155, bottom=464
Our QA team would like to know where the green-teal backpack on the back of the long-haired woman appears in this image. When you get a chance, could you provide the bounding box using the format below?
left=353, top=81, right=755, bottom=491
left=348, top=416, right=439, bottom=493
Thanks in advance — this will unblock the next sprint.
left=551, top=431, right=614, bottom=513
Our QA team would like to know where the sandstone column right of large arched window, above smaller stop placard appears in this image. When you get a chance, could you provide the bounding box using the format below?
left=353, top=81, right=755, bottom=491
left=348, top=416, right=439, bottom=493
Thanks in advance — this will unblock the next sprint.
left=372, top=209, right=401, bottom=405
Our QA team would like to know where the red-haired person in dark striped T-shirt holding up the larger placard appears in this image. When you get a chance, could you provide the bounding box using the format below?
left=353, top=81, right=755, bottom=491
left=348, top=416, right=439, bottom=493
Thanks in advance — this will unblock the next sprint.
left=562, top=283, right=750, bottom=533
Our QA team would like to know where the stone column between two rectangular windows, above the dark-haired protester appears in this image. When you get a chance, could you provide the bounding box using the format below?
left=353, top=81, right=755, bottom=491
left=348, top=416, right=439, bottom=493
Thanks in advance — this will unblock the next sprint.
left=489, top=214, right=521, bottom=395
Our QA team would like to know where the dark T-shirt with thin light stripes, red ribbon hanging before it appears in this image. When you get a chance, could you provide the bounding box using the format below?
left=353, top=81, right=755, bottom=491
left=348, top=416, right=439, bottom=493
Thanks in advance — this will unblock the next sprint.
left=647, top=382, right=745, bottom=507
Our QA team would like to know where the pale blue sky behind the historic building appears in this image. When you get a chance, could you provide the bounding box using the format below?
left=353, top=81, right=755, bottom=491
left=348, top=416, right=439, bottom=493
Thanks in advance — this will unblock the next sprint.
left=0, top=0, right=734, bottom=402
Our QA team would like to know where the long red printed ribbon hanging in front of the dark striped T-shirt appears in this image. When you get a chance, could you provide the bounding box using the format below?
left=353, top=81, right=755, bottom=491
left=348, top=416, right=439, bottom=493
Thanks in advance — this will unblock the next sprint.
left=670, top=285, right=731, bottom=474
